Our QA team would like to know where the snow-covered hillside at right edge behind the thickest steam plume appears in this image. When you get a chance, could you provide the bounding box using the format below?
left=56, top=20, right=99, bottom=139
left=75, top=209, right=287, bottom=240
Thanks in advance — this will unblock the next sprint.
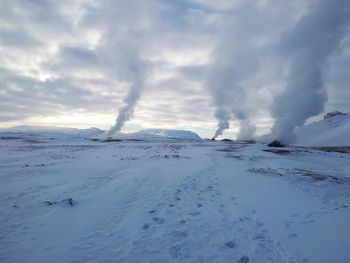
left=295, top=112, right=350, bottom=146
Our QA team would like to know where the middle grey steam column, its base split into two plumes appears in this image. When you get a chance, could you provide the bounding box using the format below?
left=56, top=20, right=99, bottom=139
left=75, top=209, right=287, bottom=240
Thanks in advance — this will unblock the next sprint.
left=207, top=5, right=259, bottom=139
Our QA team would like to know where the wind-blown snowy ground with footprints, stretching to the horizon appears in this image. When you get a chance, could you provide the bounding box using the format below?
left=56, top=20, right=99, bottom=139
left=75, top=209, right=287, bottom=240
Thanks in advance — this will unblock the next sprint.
left=0, top=133, right=350, bottom=263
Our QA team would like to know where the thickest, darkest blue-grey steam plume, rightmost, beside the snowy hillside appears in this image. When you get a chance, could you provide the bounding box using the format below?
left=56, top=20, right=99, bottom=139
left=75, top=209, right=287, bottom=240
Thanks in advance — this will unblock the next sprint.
left=271, top=0, right=350, bottom=143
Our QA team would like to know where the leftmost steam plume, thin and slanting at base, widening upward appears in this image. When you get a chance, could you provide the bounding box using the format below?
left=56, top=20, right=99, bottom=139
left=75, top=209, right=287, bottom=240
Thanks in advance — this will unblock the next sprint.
left=98, top=0, right=154, bottom=137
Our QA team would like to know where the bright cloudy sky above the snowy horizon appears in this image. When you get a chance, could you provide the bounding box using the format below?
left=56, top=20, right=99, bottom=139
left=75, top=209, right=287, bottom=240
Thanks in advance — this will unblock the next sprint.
left=0, top=0, right=350, bottom=137
